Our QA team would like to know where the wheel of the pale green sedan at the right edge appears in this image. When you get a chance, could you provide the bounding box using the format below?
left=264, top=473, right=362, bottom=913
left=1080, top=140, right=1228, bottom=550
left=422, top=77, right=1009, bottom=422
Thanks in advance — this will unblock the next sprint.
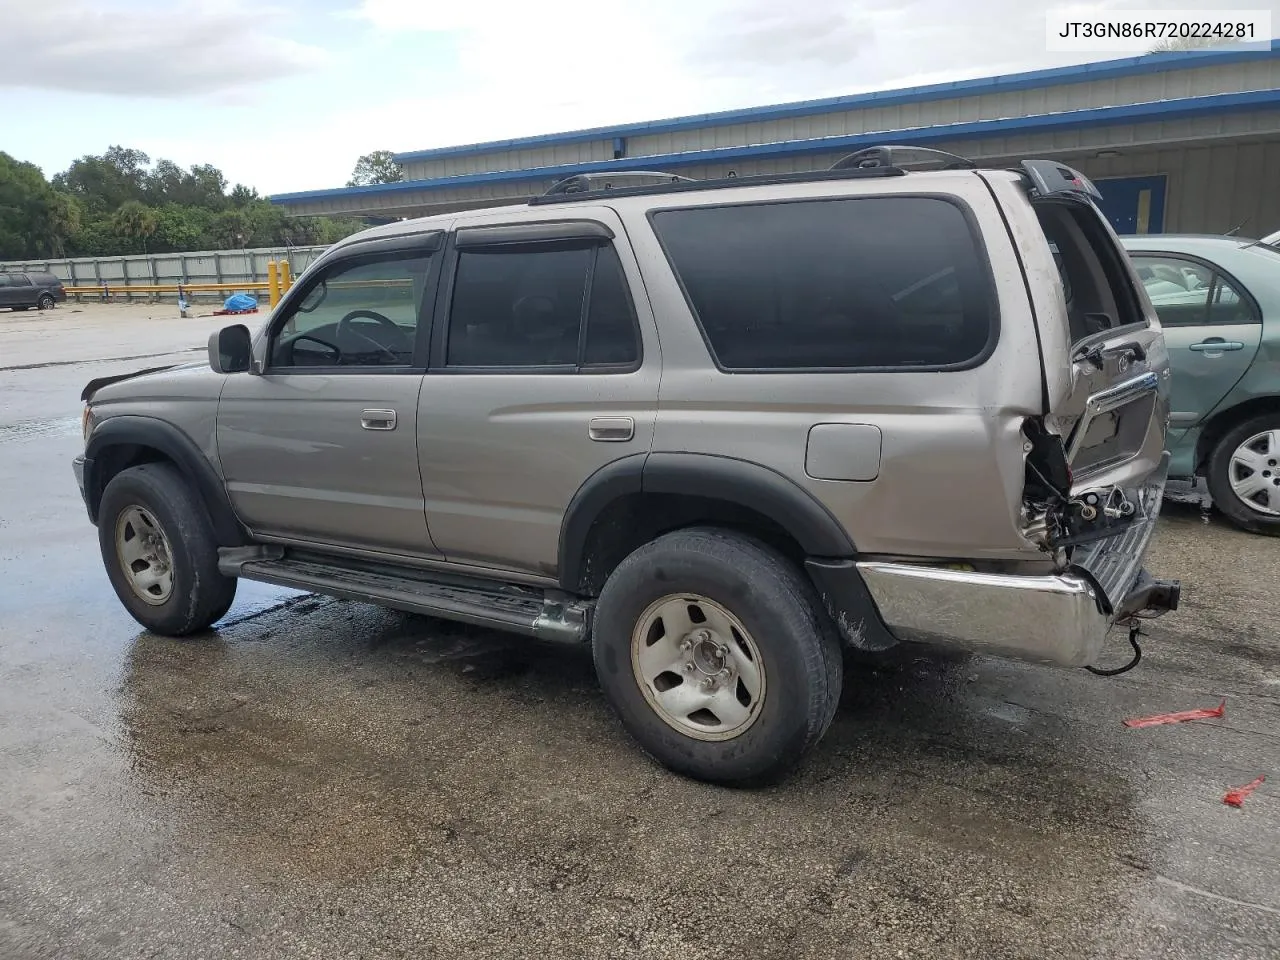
left=1206, top=412, right=1280, bottom=536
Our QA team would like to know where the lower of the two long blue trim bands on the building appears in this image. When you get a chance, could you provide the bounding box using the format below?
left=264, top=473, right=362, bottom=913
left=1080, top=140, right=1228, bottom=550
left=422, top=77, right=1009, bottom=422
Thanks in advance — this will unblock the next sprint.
left=270, top=90, right=1280, bottom=204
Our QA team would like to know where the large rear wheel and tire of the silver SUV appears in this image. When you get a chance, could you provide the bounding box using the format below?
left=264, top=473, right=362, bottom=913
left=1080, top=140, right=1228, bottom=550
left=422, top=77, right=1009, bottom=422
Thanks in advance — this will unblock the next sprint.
left=591, top=527, right=844, bottom=786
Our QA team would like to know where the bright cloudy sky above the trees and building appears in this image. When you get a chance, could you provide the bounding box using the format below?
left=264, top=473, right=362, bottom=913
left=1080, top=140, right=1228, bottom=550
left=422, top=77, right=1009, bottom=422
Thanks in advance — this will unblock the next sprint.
left=0, top=0, right=1280, bottom=193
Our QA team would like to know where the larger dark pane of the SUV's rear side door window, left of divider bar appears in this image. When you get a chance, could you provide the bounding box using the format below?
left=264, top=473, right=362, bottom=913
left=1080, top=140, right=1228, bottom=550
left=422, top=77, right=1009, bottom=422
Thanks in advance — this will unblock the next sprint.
left=445, top=244, right=595, bottom=366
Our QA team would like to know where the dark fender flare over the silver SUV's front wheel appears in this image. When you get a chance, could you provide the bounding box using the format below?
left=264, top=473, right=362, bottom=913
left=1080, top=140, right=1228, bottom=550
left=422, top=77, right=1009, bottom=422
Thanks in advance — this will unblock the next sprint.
left=84, top=416, right=248, bottom=547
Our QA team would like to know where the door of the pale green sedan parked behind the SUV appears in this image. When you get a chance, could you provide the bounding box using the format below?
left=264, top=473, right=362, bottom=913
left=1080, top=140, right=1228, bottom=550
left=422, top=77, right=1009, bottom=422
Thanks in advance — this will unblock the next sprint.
left=1130, top=251, right=1262, bottom=443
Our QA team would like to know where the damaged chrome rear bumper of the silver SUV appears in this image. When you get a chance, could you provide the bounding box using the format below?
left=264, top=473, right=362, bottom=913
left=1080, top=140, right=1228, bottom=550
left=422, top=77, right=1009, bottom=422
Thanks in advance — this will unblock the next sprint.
left=856, top=454, right=1180, bottom=667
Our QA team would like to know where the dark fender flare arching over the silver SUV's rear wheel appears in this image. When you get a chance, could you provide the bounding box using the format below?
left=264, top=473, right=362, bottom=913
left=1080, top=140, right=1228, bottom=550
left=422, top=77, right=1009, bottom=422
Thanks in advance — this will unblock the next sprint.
left=557, top=453, right=856, bottom=590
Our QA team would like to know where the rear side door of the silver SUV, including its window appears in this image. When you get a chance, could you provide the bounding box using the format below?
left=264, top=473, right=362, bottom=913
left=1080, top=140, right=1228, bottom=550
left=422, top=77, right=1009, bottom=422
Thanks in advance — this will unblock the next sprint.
left=419, top=207, right=660, bottom=576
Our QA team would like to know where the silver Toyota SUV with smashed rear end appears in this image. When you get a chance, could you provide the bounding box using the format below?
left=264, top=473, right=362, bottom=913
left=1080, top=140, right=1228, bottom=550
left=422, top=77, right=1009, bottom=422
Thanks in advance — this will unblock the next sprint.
left=76, top=147, right=1179, bottom=783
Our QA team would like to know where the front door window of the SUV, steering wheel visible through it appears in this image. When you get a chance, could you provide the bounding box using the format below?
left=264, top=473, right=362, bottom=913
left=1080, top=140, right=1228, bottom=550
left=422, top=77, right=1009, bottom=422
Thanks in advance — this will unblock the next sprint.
left=271, top=256, right=429, bottom=366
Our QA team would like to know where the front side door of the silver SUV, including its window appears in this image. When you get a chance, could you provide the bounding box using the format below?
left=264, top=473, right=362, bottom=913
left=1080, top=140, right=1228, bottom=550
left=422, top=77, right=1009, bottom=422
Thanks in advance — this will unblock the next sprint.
left=218, top=233, right=440, bottom=557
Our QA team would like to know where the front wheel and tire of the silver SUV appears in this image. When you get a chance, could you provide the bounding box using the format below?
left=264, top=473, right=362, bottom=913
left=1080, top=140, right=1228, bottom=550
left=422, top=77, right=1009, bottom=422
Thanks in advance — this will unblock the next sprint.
left=97, top=463, right=236, bottom=636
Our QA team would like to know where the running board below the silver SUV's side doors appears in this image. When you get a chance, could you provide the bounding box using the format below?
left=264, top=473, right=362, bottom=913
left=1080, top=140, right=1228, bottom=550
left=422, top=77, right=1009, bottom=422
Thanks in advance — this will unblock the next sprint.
left=220, top=552, right=595, bottom=644
